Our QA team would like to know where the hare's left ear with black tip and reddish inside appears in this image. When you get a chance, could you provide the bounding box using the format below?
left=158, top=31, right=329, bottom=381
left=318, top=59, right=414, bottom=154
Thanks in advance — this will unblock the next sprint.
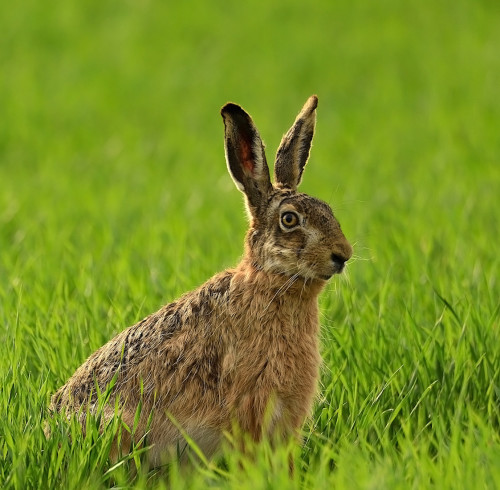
left=221, top=103, right=272, bottom=217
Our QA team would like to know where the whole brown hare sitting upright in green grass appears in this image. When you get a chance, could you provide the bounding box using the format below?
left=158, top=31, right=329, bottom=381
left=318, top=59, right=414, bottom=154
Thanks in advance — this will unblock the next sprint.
left=50, top=95, right=352, bottom=465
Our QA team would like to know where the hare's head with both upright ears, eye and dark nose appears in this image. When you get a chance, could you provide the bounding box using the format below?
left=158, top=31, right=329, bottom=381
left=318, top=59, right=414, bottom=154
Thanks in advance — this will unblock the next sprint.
left=221, top=95, right=352, bottom=281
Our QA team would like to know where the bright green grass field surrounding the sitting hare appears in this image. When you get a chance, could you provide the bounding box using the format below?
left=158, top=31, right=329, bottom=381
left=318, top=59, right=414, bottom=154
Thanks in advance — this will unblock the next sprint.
left=0, top=0, right=500, bottom=490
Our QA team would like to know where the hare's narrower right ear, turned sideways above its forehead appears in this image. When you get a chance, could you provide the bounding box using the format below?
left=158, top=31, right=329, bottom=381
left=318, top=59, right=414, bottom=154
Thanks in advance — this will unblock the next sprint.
left=274, top=95, right=318, bottom=190
